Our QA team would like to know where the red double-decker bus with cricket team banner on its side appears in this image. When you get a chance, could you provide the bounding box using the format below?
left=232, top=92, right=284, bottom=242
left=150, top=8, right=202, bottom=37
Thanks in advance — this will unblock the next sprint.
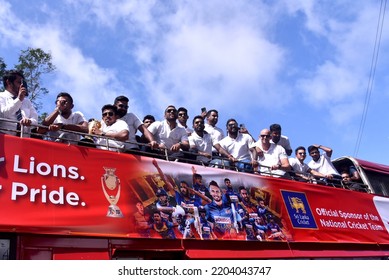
left=0, top=123, right=389, bottom=260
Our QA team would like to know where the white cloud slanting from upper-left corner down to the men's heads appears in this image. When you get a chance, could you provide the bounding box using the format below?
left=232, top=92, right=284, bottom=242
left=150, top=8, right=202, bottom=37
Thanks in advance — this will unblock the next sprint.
left=0, top=0, right=122, bottom=117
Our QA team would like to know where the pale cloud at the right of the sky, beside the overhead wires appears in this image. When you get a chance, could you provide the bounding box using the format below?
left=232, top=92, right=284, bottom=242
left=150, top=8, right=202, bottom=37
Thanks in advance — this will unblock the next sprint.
left=297, top=2, right=379, bottom=124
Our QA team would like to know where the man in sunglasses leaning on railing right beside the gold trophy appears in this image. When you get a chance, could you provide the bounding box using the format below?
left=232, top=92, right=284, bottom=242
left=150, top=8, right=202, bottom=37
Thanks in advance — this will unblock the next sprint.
left=91, top=104, right=129, bottom=151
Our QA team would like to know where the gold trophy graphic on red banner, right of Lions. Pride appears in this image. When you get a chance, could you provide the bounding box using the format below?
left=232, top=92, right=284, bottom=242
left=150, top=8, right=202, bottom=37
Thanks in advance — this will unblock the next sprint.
left=101, top=167, right=123, bottom=218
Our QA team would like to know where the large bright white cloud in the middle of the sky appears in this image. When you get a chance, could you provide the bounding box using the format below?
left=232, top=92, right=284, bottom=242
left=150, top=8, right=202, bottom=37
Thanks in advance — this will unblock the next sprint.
left=116, top=1, right=287, bottom=115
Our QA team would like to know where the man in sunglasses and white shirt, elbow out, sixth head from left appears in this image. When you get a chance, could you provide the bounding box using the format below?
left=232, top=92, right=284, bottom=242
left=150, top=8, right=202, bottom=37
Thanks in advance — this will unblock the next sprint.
left=147, top=105, right=189, bottom=157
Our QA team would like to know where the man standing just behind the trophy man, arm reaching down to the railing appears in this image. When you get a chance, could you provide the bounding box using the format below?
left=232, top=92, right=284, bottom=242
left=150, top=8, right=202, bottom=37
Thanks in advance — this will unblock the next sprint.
left=113, top=95, right=158, bottom=150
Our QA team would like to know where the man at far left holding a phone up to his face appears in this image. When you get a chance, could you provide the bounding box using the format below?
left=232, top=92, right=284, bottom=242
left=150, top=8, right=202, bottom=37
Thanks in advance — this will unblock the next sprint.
left=0, top=70, right=38, bottom=135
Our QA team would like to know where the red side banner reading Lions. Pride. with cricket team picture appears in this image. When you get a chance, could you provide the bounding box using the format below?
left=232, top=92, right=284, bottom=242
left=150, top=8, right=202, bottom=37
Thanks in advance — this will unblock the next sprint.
left=0, top=134, right=389, bottom=244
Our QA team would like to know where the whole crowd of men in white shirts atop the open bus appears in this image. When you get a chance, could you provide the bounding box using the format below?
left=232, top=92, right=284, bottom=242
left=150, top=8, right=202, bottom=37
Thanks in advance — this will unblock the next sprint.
left=0, top=70, right=360, bottom=189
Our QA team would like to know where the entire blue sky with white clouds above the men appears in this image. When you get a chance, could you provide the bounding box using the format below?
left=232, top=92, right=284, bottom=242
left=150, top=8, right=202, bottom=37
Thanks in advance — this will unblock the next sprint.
left=0, top=0, right=389, bottom=165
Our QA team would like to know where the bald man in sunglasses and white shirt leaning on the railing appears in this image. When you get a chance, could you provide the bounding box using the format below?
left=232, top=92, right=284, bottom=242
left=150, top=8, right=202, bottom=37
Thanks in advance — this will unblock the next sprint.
left=255, top=128, right=291, bottom=177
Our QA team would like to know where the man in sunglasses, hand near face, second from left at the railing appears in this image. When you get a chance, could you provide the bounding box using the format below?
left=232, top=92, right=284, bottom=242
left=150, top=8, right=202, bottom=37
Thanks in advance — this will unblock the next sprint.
left=38, top=92, right=88, bottom=144
